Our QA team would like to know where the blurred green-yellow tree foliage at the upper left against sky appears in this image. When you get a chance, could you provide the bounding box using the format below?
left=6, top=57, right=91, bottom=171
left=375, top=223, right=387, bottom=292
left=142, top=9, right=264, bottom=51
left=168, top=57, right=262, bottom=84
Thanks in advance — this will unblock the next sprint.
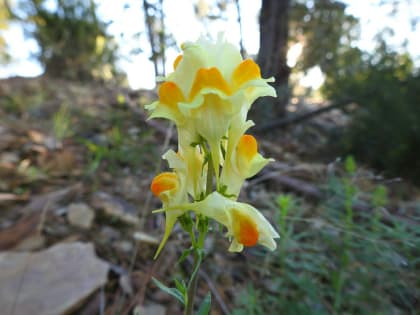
left=9, top=0, right=118, bottom=80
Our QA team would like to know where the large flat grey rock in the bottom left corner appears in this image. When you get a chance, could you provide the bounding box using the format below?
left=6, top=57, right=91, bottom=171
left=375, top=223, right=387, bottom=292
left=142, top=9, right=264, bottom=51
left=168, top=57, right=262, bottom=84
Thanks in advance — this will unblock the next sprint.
left=0, top=243, right=109, bottom=315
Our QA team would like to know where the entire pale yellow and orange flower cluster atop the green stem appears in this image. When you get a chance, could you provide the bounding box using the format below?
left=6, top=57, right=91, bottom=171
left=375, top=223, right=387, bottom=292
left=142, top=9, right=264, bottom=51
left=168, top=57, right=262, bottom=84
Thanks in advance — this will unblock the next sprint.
left=146, top=38, right=279, bottom=256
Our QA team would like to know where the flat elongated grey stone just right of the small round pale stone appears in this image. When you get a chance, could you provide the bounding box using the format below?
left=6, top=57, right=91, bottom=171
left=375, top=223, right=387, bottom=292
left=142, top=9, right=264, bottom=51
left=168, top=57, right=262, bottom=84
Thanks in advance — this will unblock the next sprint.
left=91, top=192, right=140, bottom=225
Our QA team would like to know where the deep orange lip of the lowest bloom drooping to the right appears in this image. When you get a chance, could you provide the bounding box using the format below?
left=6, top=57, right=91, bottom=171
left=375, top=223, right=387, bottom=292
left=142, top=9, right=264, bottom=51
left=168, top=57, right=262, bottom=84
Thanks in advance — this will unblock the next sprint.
left=232, top=209, right=259, bottom=247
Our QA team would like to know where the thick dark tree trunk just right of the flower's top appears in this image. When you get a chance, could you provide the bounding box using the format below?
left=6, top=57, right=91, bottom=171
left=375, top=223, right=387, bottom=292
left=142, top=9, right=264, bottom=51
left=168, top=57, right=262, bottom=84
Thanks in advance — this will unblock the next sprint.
left=250, top=0, right=290, bottom=123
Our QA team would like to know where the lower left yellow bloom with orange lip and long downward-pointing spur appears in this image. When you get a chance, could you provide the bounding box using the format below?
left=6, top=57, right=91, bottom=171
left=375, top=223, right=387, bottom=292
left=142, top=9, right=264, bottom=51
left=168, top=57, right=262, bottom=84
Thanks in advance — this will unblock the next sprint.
left=150, top=172, right=186, bottom=258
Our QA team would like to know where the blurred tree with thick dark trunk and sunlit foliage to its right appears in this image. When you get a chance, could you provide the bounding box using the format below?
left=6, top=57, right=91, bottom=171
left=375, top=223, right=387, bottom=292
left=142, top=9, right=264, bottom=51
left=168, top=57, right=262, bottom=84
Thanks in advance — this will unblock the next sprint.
left=251, top=0, right=359, bottom=122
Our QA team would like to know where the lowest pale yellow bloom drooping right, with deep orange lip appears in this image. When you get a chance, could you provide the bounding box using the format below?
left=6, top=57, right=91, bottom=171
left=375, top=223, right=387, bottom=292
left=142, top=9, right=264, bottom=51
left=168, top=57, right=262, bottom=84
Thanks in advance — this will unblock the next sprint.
left=161, top=192, right=280, bottom=252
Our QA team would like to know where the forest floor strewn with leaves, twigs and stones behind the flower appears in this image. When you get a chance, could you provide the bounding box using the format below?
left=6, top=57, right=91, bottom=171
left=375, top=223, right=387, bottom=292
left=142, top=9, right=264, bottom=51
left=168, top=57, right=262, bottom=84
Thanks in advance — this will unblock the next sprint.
left=0, top=77, right=420, bottom=315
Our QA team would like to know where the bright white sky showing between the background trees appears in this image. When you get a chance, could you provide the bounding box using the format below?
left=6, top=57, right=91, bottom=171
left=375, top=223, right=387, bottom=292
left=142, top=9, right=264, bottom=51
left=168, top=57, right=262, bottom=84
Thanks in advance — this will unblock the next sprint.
left=0, top=0, right=420, bottom=88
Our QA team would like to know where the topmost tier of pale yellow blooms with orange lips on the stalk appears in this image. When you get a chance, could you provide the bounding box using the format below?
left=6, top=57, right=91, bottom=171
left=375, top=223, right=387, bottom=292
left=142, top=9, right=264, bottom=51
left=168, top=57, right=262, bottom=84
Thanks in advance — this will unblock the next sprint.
left=146, top=38, right=276, bottom=178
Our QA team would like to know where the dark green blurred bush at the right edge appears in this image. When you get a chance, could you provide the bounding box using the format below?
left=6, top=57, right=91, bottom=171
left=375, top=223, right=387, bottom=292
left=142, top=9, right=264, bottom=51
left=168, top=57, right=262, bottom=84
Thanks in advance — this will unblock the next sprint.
left=322, top=42, right=420, bottom=183
